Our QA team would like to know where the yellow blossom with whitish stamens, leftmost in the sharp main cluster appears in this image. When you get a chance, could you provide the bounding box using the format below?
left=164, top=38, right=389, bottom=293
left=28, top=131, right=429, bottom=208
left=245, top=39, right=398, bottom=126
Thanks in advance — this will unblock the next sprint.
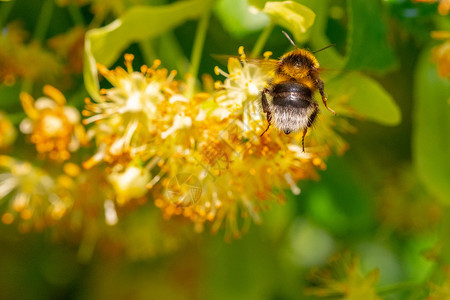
left=83, top=54, right=185, bottom=168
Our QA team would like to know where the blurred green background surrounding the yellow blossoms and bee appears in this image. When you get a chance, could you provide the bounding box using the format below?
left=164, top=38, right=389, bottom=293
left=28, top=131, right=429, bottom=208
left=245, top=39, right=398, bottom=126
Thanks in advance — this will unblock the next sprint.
left=0, top=0, right=450, bottom=299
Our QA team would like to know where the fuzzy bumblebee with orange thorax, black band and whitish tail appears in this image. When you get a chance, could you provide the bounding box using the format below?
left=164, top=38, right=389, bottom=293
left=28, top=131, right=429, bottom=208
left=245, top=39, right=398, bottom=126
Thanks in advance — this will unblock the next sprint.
left=261, top=31, right=336, bottom=152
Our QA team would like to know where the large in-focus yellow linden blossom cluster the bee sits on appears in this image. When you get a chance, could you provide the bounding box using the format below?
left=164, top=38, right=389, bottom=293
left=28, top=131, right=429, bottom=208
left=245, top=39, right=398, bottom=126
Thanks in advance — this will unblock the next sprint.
left=78, top=47, right=342, bottom=237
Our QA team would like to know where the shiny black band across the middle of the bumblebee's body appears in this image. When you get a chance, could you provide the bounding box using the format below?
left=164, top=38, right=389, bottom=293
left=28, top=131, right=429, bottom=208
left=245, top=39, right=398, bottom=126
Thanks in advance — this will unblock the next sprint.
left=271, top=82, right=312, bottom=108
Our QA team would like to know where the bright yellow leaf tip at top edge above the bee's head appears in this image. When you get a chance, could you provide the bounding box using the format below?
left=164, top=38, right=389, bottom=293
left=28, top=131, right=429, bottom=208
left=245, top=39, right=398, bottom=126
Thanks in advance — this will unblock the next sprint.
left=263, top=1, right=316, bottom=41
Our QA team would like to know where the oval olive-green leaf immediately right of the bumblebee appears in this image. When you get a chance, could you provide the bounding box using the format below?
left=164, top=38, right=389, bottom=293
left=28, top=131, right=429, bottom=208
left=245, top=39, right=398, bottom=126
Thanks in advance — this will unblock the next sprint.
left=326, top=72, right=401, bottom=126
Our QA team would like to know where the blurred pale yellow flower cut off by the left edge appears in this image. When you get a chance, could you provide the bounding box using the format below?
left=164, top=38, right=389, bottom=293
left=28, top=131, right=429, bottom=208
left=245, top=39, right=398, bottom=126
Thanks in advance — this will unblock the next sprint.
left=0, top=155, right=72, bottom=230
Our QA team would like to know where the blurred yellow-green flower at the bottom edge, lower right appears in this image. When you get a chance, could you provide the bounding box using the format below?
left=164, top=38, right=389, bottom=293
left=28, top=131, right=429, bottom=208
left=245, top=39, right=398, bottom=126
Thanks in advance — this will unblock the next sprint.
left=305, top=253, right=381, bottom=300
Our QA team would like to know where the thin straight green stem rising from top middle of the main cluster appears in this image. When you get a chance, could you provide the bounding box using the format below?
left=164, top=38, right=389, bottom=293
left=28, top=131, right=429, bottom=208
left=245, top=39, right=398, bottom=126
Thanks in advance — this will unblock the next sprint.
left=186, top=3, right=211, bottom=99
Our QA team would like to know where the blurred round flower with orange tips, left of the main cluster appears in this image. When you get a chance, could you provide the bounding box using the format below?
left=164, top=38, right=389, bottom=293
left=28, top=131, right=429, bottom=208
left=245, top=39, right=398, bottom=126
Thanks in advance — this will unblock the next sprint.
left=20, top=85, right=87, bottom=161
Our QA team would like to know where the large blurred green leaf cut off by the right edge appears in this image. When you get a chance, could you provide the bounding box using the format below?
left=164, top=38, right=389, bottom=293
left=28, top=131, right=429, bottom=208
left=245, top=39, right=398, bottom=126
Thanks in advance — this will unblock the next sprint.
left=412, top=49, right=450, bottom=204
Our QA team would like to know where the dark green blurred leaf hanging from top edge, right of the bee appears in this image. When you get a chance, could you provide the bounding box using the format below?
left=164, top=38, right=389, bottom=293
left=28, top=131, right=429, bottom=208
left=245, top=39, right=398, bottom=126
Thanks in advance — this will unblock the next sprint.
left=345, top=0, right=395, bottom=71
